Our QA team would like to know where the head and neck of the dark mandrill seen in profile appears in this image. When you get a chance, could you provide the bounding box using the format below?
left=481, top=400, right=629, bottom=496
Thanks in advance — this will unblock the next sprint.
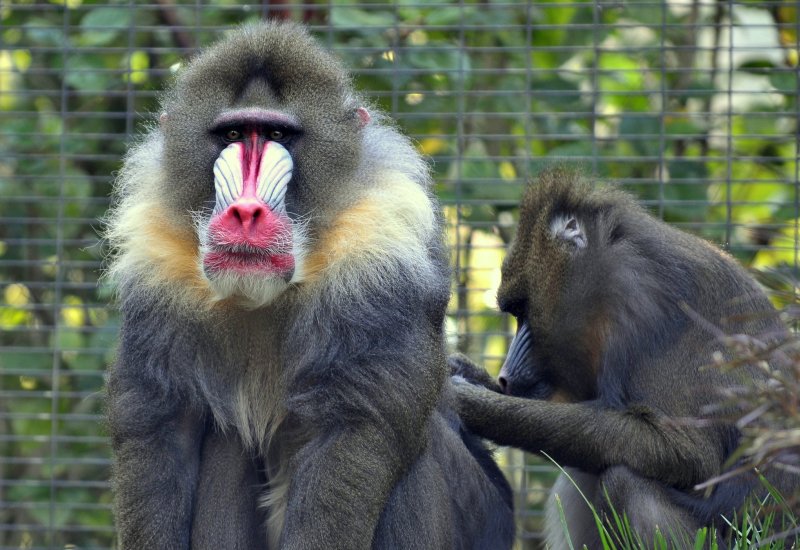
left=498, top=168, right=696, bottom=401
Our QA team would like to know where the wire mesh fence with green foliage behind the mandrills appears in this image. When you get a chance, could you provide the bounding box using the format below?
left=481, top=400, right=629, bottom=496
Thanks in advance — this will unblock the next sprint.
left=0, top=0, right=800, bottom=548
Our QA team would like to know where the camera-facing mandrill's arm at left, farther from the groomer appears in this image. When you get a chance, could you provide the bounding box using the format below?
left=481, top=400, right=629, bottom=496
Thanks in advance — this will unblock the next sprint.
left=108, top=302, right=204, bottom=550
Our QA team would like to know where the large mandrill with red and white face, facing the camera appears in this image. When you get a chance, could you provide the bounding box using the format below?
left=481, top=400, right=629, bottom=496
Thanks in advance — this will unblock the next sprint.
left=108, top=23, right=513, bottom=550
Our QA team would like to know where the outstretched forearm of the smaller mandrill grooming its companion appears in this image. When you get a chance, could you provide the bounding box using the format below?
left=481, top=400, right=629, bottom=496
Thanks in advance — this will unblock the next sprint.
left=455, top=382, right=722, bottom=488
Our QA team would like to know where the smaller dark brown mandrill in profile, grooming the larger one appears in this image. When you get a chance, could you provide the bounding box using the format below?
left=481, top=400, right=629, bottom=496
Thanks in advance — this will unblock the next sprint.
left=451, top=170, right=797, bottom=549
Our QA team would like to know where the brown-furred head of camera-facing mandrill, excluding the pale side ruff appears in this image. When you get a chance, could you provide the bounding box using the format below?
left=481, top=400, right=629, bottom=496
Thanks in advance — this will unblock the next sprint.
left=138, top=26, right=370, bottom=309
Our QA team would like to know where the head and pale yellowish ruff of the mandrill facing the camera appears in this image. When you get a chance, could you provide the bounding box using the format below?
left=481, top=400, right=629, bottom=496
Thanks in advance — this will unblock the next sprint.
left=108, top=23, right=436, bottom=309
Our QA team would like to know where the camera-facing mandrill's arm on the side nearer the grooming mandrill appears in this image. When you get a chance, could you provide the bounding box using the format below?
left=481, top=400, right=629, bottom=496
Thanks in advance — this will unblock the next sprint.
left=280, top=286, right=447, bottom=550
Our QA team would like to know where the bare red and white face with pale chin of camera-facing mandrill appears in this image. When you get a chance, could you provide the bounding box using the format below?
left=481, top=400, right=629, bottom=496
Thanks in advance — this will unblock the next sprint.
left=198, top=115, right=303, bottom=307
